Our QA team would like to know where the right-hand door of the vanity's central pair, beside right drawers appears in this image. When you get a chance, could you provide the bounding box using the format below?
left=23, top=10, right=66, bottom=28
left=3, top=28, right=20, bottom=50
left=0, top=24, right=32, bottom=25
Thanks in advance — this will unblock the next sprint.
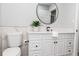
left=54, top=40, right=65, bottom=56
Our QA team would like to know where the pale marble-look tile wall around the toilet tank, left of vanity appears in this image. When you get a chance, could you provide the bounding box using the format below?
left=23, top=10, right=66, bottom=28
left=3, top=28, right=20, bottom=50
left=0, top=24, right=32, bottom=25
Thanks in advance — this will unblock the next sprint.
left=0, top=27, right=28, bottom=56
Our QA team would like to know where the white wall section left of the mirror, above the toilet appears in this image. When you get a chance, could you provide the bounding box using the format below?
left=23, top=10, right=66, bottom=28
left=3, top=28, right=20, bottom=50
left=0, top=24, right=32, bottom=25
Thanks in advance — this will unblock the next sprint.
left=0, top=3, right=36, bottom=26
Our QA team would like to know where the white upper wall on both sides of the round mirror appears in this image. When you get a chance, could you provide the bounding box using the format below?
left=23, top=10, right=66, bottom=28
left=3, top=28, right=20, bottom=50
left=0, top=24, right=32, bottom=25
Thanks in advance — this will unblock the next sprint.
left=0, top=3, right=75, bottom=28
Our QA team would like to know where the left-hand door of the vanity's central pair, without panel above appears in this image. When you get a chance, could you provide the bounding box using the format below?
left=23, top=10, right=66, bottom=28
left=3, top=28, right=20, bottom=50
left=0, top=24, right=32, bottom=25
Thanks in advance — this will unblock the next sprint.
left=42, top=40, right=54, bottom=56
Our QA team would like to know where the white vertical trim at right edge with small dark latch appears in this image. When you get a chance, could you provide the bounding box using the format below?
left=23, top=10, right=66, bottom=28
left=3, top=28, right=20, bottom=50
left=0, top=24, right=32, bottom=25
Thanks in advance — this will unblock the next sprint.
left=73, top=3, right=79, bottom=56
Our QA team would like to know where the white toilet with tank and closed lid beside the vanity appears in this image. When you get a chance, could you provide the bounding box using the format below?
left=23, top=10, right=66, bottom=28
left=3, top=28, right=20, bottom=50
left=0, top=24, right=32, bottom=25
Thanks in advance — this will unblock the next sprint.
left=3, top=32, right=22, bottom=56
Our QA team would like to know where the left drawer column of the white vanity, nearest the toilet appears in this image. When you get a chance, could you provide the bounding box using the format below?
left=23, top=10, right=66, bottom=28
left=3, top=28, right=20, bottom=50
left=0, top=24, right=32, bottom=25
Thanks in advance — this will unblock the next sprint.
left=28, top=34, right=41, bottom=56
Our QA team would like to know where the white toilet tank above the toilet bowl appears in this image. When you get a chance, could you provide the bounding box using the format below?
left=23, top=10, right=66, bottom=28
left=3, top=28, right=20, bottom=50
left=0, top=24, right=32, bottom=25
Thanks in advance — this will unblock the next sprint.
left=7, top=32, right=22, bottom=47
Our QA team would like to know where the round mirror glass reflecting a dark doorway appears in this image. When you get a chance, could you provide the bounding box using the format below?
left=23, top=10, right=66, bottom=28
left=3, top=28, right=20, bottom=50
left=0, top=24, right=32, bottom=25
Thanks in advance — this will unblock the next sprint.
left=36, top=3, right=58, bottom=24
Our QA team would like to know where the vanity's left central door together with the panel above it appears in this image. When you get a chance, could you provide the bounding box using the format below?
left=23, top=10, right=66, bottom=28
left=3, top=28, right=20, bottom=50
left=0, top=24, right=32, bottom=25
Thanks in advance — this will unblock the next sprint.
left=41, top=33, right=55, bottom=56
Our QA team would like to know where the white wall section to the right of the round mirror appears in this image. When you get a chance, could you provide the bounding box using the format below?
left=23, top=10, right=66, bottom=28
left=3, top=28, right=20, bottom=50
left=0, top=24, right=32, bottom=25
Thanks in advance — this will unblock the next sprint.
left=52, top=3, right=76, bottom=29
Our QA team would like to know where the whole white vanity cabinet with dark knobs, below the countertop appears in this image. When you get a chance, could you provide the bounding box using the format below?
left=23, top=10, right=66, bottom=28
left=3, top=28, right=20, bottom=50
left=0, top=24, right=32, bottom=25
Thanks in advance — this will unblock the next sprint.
left=28, top=32, right=74, bottom=56
